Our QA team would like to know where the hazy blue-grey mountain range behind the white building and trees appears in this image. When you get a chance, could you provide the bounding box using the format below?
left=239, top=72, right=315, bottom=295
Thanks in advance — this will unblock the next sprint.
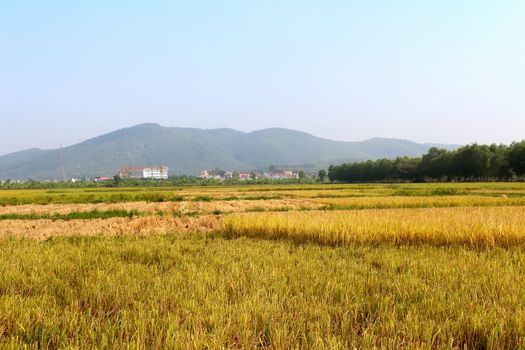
left=0, top=123, right=457, bottom=180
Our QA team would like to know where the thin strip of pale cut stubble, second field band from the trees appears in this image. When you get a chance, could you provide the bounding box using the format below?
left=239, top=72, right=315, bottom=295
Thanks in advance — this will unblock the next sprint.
left=0, top=195, right=525, bottom=220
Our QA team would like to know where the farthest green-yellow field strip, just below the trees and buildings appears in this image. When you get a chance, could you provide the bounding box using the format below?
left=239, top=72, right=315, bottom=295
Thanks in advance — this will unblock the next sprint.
left=0, top=183, right=525, bottom=206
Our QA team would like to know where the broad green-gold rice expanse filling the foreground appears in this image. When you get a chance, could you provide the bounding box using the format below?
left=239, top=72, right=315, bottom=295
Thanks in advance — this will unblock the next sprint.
left=0, top=234, right=525, bottom=349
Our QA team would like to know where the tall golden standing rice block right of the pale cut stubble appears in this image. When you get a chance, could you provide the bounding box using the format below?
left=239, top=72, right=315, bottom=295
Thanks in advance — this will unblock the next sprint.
left=224, top=207, right=525, bottom=247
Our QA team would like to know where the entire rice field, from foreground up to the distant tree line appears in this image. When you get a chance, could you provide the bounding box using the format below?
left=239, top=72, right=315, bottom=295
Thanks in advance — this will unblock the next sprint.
left=0, top=183, right=525, bottom=349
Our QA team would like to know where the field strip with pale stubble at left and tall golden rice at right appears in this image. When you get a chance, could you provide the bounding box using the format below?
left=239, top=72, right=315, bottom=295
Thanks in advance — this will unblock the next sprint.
left=0, top=207, right=525, bottom=248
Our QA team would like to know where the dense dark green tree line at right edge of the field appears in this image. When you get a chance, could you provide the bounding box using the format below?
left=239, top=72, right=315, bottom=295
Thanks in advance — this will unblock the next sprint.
left=328, top=140, right=525, bottom=182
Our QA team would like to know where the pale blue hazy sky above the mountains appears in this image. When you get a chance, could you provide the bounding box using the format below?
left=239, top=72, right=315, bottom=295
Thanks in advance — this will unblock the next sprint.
left=0, top=0, right=525, bottom=154
